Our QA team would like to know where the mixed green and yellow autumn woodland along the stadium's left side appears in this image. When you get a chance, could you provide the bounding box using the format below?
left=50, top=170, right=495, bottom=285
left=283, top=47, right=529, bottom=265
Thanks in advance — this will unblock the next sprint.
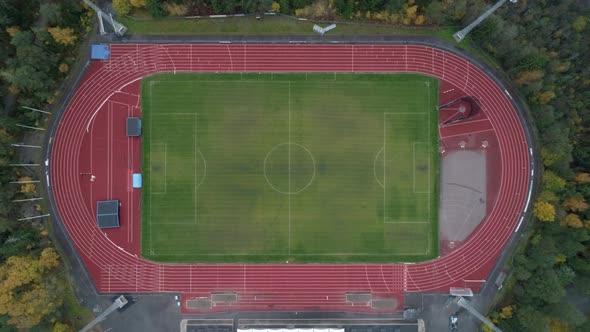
left=0, top=0, right=94, bottom=332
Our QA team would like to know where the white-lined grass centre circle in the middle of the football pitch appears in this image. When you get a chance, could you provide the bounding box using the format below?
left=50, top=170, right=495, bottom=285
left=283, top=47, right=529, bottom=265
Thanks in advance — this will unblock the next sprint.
left=264, top=143, right=315, bottom=195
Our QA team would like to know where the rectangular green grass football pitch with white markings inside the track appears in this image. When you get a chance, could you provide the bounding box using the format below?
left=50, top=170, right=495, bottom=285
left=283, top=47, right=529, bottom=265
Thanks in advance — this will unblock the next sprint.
left=142, top=73, right=439, bottom=263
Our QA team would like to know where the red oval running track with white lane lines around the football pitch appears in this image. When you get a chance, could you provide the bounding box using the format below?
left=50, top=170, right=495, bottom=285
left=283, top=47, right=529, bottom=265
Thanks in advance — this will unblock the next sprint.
left=50, top=44, right=530, bottom=312
